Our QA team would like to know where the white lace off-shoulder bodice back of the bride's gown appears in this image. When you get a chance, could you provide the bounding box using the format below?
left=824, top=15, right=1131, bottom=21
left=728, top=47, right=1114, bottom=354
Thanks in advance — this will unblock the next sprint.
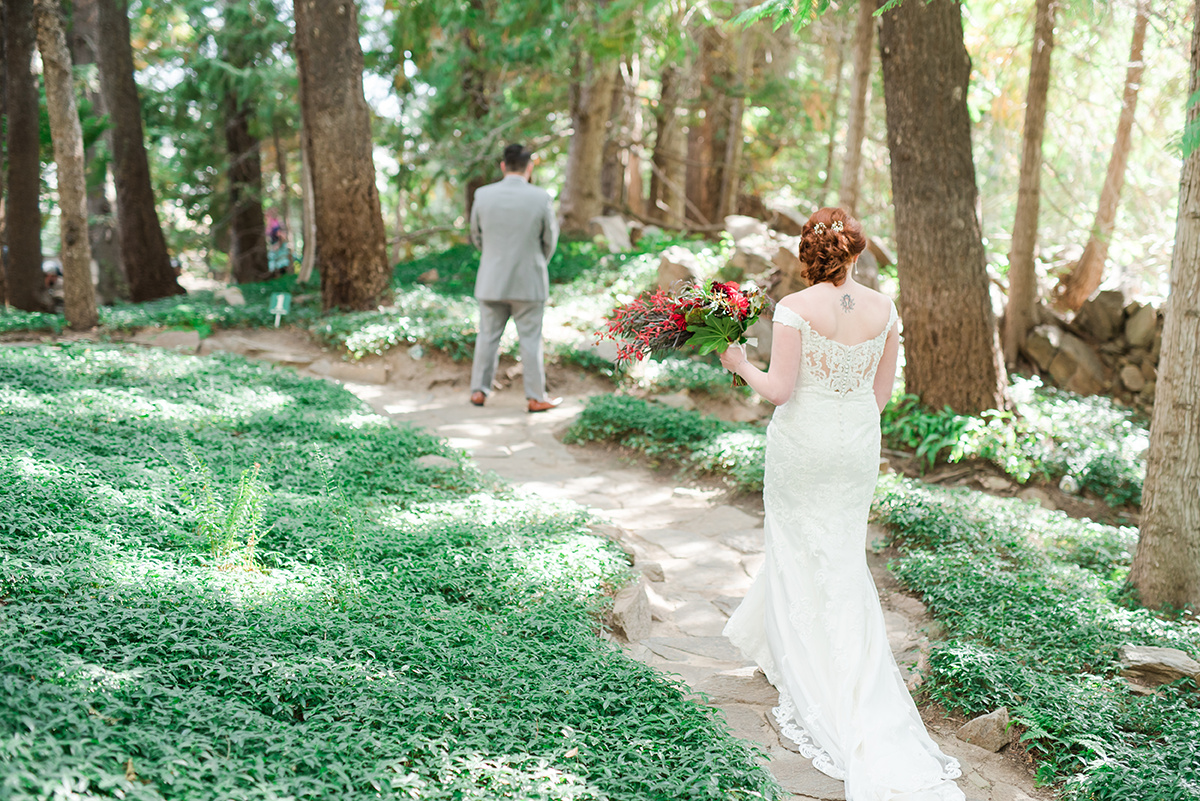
left=774, top=303, right=896, bottom=395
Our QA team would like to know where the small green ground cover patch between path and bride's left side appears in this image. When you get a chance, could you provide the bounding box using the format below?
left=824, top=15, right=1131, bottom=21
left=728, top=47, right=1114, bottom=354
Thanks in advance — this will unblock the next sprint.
left=563, top=395, right=767, bottom=492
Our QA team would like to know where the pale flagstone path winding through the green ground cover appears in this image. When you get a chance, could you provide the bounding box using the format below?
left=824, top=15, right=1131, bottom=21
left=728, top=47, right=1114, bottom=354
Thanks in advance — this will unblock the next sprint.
left=87, top=329, right=1054, bottom=801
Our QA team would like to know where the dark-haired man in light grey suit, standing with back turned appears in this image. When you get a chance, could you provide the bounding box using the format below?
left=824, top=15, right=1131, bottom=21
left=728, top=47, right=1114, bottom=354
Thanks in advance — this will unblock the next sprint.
left=470, top=145, right=562, bottom=411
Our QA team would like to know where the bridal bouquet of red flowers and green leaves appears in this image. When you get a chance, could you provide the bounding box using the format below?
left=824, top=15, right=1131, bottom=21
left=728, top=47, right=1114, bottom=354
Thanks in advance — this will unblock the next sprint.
left=596, top=281, right=770, bottom=363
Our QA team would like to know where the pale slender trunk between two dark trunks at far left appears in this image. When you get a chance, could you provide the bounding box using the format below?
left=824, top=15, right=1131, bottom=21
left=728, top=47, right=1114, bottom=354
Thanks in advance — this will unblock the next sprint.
left=34, top=0, right=100, bottom=331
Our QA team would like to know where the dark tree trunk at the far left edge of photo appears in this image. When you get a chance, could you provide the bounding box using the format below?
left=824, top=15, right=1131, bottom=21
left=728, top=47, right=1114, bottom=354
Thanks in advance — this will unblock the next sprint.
left=5, top=0, right=52, bottom=312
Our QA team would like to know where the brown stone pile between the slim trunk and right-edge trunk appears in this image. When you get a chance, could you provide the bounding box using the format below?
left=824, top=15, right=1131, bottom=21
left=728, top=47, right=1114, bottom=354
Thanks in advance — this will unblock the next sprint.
left=1022, top=291, right=1163, bottom=408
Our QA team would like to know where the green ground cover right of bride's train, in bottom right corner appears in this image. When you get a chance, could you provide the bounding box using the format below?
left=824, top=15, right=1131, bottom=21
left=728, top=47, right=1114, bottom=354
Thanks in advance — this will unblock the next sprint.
left=874, top=477, right=1200, bottom=801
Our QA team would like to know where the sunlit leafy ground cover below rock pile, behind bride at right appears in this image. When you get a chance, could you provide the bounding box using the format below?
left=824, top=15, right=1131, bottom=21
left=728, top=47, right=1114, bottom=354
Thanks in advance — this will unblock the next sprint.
left=882, top=377, right=1150, bottom=506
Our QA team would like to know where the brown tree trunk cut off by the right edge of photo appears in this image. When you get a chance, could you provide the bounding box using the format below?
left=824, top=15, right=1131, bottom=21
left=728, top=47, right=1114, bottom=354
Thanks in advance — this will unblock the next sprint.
left=1129, top=1, right=1200, bottom=610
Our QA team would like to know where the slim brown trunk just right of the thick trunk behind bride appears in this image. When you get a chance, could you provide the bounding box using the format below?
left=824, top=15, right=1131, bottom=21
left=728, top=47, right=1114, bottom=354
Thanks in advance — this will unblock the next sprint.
left=1003, top=0, right=1058, bottom=369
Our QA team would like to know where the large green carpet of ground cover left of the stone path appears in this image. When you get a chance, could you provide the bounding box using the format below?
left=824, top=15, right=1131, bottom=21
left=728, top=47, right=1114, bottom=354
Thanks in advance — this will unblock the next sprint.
left=0, top=344, right=773, bottom=801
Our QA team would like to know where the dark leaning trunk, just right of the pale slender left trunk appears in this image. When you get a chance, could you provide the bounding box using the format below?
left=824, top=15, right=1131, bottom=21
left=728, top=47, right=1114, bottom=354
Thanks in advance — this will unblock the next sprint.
left=97, top=0, right=184, bottom=303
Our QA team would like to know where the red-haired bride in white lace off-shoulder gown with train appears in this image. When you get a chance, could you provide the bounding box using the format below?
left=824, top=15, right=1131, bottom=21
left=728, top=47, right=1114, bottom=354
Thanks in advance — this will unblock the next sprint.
left=721, top=209, right=964, bottom=801
